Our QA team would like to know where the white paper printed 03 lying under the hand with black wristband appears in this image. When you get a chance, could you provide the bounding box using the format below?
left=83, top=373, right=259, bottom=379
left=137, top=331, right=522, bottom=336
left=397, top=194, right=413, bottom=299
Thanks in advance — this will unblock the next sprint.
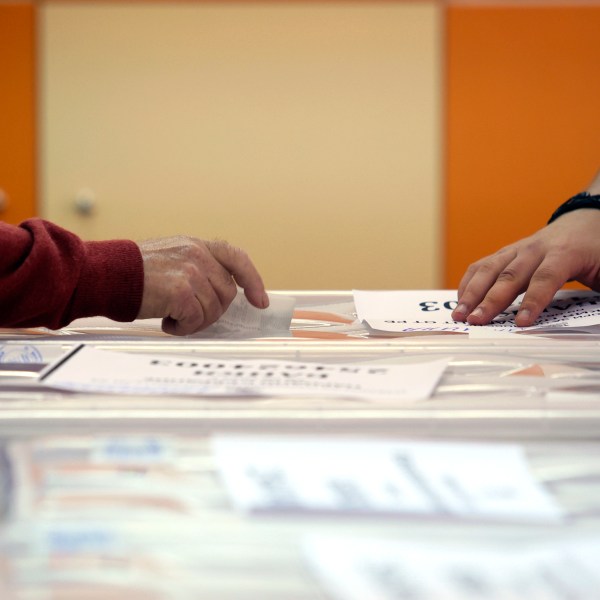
left=353, top=290, right=600, bottom=334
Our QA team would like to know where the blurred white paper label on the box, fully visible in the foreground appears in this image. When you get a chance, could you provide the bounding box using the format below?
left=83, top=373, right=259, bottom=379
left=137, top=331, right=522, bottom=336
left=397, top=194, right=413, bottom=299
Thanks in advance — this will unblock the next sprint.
left=212, top=435, right=562, bottom=522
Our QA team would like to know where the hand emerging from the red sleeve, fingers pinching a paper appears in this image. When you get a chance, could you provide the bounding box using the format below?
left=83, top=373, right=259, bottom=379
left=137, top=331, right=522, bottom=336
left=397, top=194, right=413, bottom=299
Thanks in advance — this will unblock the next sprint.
left=138, top=236, right=269, bottom=335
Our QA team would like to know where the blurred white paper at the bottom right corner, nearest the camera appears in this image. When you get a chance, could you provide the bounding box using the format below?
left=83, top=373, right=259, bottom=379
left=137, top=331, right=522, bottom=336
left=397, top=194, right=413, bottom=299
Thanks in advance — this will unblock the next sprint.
left=303, top=536, right=600, bottom=600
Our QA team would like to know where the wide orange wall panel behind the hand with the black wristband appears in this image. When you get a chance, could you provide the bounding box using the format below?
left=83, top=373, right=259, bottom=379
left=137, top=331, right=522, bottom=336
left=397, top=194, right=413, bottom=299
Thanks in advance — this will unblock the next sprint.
left=445, top=5, right=600, bottom=288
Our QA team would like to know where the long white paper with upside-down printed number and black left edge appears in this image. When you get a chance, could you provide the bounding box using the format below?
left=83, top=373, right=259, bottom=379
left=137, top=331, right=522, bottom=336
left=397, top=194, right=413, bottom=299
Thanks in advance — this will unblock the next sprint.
left=40, top=345, right=448, bottom=401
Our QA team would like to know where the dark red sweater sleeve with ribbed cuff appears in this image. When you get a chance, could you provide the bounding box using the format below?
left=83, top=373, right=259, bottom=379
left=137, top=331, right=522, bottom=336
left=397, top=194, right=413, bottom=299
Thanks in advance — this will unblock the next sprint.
left=0, top=219, right=144, bottom=329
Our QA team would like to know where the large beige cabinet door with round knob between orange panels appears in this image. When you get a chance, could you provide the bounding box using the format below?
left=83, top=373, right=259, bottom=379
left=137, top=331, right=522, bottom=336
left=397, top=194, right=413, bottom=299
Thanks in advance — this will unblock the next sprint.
left=40, top=2, right=441, bottom=289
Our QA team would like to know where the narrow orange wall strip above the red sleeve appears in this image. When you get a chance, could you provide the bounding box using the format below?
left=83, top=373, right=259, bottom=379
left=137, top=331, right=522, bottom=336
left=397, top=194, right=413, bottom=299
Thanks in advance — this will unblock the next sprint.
left=0, top=2, right=36, bottom=223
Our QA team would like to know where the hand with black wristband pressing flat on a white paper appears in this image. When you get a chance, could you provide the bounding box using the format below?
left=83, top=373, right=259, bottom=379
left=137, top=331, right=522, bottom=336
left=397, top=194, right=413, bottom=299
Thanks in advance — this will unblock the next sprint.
left=452, top=208, right=600, bottom=327
